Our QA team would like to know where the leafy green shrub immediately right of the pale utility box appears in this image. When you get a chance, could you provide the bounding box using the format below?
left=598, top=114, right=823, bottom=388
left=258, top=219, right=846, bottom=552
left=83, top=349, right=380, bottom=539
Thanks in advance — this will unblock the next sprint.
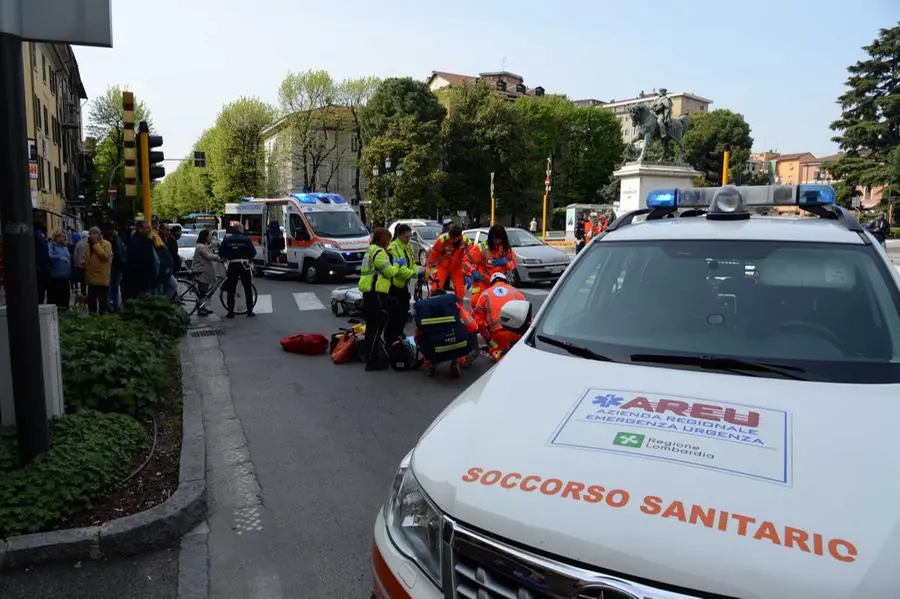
left=60, top=316, right=174, bottom=416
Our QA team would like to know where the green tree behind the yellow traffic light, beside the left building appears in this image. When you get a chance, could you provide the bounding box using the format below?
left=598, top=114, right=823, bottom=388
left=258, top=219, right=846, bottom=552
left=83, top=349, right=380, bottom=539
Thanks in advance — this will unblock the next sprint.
left=85, top=85, right=153, bottom=213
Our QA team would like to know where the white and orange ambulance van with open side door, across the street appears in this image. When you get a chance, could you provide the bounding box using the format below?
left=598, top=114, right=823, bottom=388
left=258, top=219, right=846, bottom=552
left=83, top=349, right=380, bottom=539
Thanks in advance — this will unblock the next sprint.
left=224, top=193, right=369, bottom=283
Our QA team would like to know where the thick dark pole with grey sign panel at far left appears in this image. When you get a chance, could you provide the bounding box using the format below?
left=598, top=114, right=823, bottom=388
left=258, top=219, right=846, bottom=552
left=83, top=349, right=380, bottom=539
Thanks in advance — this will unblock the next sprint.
left=0, top=0, right=112, bottom=465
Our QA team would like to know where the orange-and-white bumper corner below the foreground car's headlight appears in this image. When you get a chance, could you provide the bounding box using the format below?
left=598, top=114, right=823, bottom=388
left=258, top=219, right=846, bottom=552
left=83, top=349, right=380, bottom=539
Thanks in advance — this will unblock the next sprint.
left=372, top=510, right=444, bottom=599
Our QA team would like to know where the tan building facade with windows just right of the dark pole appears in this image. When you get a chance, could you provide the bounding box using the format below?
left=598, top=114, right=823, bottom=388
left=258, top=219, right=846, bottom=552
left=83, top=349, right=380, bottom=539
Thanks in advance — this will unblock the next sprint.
left=22, top=42, right=87, bottom=233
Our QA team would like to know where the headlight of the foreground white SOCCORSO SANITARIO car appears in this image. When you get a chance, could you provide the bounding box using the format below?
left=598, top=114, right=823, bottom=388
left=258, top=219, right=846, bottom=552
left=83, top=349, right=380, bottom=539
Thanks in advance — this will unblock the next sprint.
left=384, top=452, right=441, bottom=587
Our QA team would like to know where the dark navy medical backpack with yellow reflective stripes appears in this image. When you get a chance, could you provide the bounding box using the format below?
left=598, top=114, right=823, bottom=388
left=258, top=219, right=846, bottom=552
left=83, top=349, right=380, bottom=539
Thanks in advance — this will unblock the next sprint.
left=415, top=294, right=476, bottom=363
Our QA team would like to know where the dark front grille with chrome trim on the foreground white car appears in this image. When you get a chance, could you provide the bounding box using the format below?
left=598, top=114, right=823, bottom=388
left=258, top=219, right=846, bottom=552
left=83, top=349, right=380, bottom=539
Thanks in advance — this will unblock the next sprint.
left=444, top=519, right=712, bottom=599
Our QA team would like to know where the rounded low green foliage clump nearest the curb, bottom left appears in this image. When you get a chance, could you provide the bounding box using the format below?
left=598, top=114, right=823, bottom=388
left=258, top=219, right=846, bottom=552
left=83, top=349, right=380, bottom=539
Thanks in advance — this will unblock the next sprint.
left=0, top=411, right=148, bottom=538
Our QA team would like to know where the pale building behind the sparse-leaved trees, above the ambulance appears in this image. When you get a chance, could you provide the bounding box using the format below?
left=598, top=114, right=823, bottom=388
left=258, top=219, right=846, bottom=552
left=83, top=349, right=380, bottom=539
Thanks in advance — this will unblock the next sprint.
left=262, top=109, right=367, bottom=211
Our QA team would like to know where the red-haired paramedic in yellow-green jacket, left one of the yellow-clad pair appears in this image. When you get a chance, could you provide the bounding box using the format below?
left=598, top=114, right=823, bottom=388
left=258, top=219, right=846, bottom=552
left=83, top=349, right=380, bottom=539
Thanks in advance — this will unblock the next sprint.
left=359, top=227, right=398, bottom=370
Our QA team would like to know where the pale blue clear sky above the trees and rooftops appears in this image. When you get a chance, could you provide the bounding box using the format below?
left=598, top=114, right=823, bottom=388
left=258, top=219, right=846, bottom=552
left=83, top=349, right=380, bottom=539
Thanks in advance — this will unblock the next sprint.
left=75, top=0, right=900, bottom=164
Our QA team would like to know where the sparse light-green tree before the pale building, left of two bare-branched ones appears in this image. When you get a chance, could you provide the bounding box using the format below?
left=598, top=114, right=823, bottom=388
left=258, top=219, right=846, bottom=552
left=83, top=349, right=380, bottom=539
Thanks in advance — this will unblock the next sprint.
left=277, top=70, right=350, bottom=190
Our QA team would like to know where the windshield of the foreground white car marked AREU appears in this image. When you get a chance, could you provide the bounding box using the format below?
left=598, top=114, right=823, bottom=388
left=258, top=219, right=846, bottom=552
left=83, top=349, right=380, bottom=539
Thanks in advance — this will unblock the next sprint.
left=534, top=240, right=900, bottom=383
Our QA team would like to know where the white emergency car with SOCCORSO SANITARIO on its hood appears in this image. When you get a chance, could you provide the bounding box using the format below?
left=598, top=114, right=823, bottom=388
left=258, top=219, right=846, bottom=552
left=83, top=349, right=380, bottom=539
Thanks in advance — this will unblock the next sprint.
left=372, top=185, right=900, bottom=599
